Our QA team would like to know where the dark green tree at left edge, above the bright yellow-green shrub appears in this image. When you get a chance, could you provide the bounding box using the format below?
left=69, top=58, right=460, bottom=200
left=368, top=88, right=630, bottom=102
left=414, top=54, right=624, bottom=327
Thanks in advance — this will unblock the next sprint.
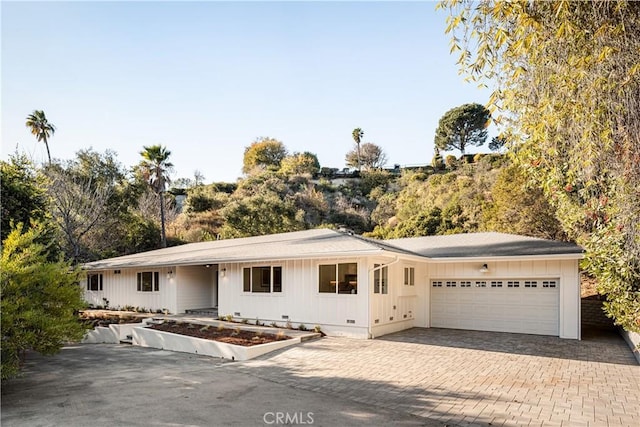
left=0, top=154, right=47, bottom=244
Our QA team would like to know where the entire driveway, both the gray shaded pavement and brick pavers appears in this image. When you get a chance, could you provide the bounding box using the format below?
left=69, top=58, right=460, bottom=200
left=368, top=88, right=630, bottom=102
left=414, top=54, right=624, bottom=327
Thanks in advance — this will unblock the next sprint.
left=2, top=329, right=640, bottom=426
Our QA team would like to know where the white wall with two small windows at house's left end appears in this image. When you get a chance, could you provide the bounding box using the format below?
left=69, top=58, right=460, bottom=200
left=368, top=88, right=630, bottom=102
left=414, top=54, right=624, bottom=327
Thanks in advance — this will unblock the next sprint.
left=81, top=267, right=177, bottom=313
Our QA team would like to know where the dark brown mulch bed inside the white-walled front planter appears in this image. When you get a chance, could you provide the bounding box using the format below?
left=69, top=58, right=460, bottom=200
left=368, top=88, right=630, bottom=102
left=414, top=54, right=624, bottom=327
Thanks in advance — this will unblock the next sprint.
left=150, top=321, right=291, bottom=347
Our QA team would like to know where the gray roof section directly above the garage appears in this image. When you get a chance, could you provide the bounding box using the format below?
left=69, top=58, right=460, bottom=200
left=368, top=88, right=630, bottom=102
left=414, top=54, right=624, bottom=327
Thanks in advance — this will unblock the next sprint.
left=385, top=232, right=583, bottom=258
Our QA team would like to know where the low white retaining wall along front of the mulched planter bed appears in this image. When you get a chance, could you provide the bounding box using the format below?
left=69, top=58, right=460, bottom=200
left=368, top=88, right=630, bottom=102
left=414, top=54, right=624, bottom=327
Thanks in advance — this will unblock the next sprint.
left=132, top=327, right=301, bottom=360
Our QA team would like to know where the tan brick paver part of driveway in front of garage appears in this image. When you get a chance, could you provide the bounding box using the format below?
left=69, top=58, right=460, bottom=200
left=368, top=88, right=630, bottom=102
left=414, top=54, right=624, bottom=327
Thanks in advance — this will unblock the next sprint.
left=234, top=328, right=640, bottom=427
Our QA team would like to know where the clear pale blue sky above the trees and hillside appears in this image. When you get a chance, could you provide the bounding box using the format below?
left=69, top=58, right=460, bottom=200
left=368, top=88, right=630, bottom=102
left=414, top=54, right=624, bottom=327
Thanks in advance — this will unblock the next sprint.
left=1, top=1, right=489, bottom=182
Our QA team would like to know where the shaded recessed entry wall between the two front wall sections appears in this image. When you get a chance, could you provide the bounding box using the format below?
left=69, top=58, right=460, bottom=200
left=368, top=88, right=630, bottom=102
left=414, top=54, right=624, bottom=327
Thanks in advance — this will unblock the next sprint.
left=175, top=265, right=216, bottom=313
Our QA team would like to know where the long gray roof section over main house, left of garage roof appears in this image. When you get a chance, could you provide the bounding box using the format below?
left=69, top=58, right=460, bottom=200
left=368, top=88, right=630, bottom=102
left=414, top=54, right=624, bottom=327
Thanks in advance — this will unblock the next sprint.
left=84, top=229, right=406, bottom=270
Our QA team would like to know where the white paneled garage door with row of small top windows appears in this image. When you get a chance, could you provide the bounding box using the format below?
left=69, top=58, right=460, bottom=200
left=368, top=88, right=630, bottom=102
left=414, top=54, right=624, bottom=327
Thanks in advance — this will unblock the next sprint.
left=431, top=279, right=560, bottom=335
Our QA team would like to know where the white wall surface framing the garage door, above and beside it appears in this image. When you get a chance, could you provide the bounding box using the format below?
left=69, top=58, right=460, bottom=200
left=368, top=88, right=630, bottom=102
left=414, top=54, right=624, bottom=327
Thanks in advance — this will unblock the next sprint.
left=425, top=260, right=580, bottom=339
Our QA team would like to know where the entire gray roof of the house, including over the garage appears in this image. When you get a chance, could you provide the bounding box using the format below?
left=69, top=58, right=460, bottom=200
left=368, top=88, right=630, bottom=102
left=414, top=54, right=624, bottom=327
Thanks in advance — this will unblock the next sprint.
left=84, top=229, right=582, bottom=270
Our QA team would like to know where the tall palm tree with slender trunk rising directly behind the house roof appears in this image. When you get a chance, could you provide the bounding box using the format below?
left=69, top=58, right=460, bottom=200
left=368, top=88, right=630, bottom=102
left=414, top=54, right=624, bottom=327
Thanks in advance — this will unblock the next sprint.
left=140, top=145, right=173, bottom=248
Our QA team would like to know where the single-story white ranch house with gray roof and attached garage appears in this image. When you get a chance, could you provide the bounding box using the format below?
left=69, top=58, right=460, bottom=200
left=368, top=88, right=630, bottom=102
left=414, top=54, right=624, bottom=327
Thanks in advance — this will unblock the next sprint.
left=84, top=229, right=583, bottom=339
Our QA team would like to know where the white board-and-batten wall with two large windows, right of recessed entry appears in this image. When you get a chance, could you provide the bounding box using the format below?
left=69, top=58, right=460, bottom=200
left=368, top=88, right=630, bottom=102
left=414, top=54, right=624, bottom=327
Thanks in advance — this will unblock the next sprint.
left=218, top=258, right=369, bottom=338
